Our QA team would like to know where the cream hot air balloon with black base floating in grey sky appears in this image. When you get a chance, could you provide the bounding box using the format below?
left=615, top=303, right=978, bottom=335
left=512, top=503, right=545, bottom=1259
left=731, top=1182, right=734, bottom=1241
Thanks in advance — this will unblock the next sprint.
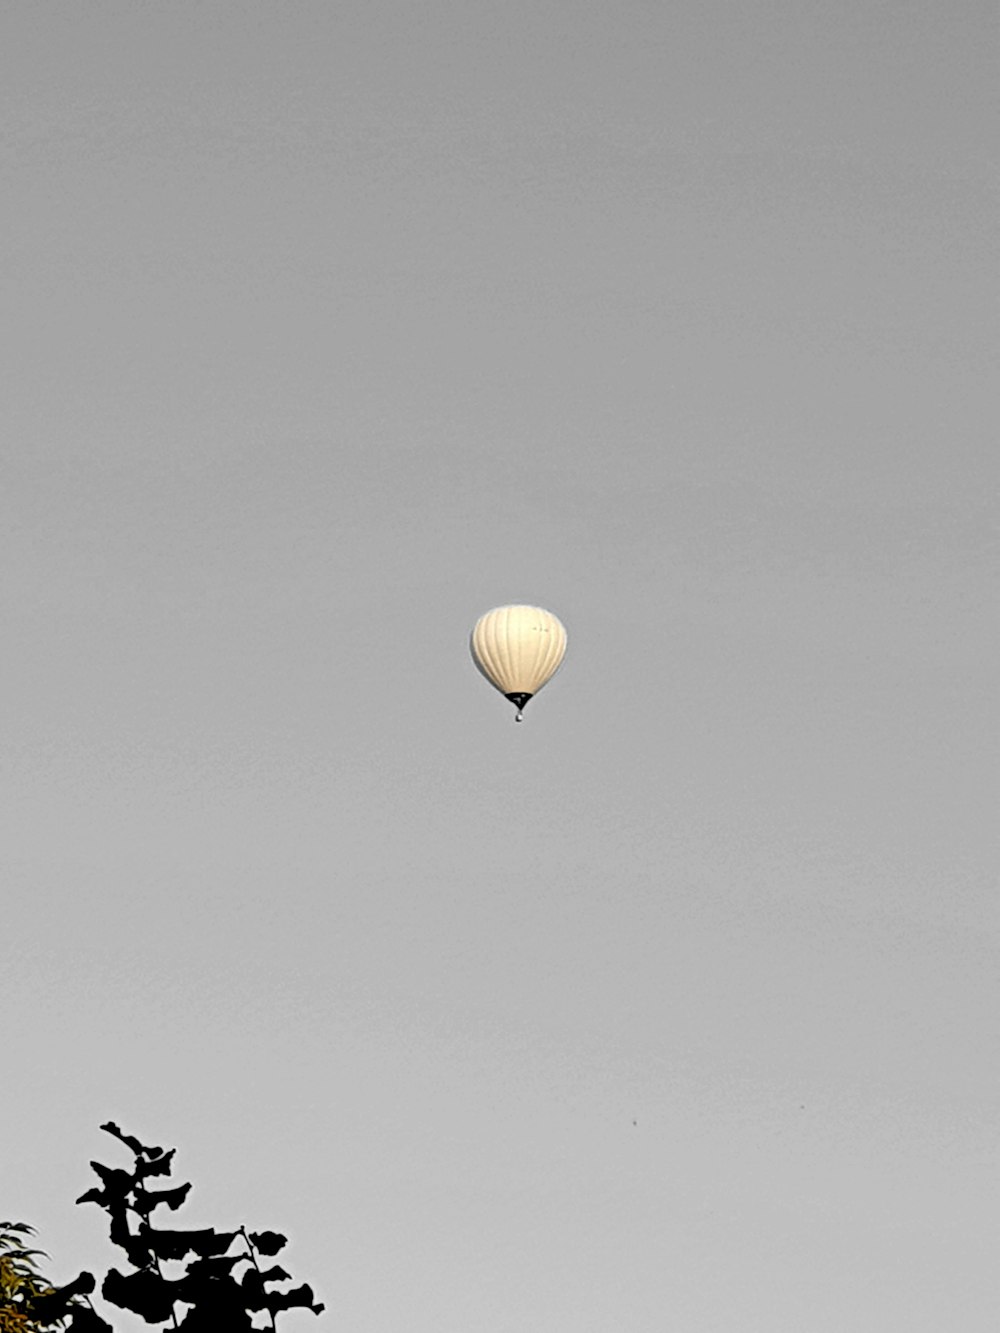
left=471, top=607, right=567, bottom=722
